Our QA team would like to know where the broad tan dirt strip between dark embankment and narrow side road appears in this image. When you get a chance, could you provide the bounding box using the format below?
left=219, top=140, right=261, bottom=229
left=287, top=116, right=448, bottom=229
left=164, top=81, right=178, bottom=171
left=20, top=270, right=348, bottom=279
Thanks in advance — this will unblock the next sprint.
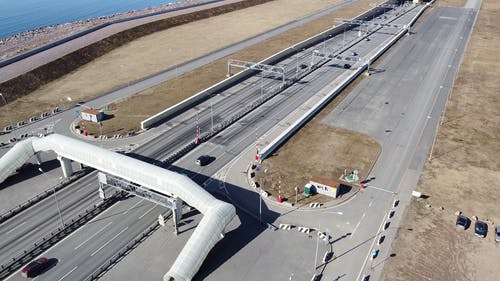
left=0, top=0, right=369, bottom=128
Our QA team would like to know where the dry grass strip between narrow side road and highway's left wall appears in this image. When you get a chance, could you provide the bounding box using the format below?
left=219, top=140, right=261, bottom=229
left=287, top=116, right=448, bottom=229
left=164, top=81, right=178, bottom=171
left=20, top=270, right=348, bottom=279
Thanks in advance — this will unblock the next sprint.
left=92, top=0, right=371, bottom=134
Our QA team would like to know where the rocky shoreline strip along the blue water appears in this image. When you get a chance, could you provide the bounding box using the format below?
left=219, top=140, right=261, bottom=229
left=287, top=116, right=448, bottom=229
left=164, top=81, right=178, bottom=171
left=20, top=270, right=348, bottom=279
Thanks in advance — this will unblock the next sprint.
left=0, top=0, right=210, bottom=61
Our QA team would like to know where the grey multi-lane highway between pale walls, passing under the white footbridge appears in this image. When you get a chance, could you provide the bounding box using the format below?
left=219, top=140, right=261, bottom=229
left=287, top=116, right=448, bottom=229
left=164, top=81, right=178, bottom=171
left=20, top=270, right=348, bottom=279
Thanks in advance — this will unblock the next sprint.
left=0, top=1, right=458, bottom=280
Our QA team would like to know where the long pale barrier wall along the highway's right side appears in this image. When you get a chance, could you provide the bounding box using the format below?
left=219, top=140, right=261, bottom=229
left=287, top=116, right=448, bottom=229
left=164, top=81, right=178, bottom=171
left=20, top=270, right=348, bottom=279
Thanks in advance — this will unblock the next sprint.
left=259, top=2, right=429, bottom=160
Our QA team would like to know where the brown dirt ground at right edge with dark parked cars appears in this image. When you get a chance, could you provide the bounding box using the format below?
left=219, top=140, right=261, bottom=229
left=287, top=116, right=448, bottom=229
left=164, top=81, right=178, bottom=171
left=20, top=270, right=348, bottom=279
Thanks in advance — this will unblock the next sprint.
left=382, top=0, right=500, bottom=281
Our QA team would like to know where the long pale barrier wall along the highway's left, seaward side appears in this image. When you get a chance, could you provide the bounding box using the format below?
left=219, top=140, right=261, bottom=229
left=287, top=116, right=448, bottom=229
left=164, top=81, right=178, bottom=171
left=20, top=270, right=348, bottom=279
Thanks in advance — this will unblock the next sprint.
left=141, top=0, right=391, bottom=130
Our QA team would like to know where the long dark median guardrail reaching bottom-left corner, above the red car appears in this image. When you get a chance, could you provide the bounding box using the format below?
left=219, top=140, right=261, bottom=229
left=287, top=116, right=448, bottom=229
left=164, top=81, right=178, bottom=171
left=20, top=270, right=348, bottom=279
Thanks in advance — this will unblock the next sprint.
left=0, top=193, right=121, bottom=279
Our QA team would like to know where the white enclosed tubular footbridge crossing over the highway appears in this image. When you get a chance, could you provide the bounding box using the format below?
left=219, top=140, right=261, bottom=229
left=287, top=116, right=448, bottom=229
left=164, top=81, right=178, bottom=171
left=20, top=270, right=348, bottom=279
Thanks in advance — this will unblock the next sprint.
left=0, top=134, right=236, bottom=281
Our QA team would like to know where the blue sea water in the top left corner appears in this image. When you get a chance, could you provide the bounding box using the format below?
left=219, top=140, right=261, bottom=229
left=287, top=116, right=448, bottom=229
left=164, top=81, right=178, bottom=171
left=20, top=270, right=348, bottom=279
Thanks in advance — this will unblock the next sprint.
left=0, top=0, right=182, bottom=38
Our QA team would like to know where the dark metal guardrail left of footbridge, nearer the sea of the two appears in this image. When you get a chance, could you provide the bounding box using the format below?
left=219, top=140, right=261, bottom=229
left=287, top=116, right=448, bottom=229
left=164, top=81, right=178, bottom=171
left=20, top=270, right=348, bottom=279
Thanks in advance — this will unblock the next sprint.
left=0, top=167, right=93, bottom=224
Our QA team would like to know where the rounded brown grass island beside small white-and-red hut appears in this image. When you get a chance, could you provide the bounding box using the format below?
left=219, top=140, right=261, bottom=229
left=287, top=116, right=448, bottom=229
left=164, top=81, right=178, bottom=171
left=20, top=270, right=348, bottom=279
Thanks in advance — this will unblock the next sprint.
left=256, top=121, right=380, bottom=204
